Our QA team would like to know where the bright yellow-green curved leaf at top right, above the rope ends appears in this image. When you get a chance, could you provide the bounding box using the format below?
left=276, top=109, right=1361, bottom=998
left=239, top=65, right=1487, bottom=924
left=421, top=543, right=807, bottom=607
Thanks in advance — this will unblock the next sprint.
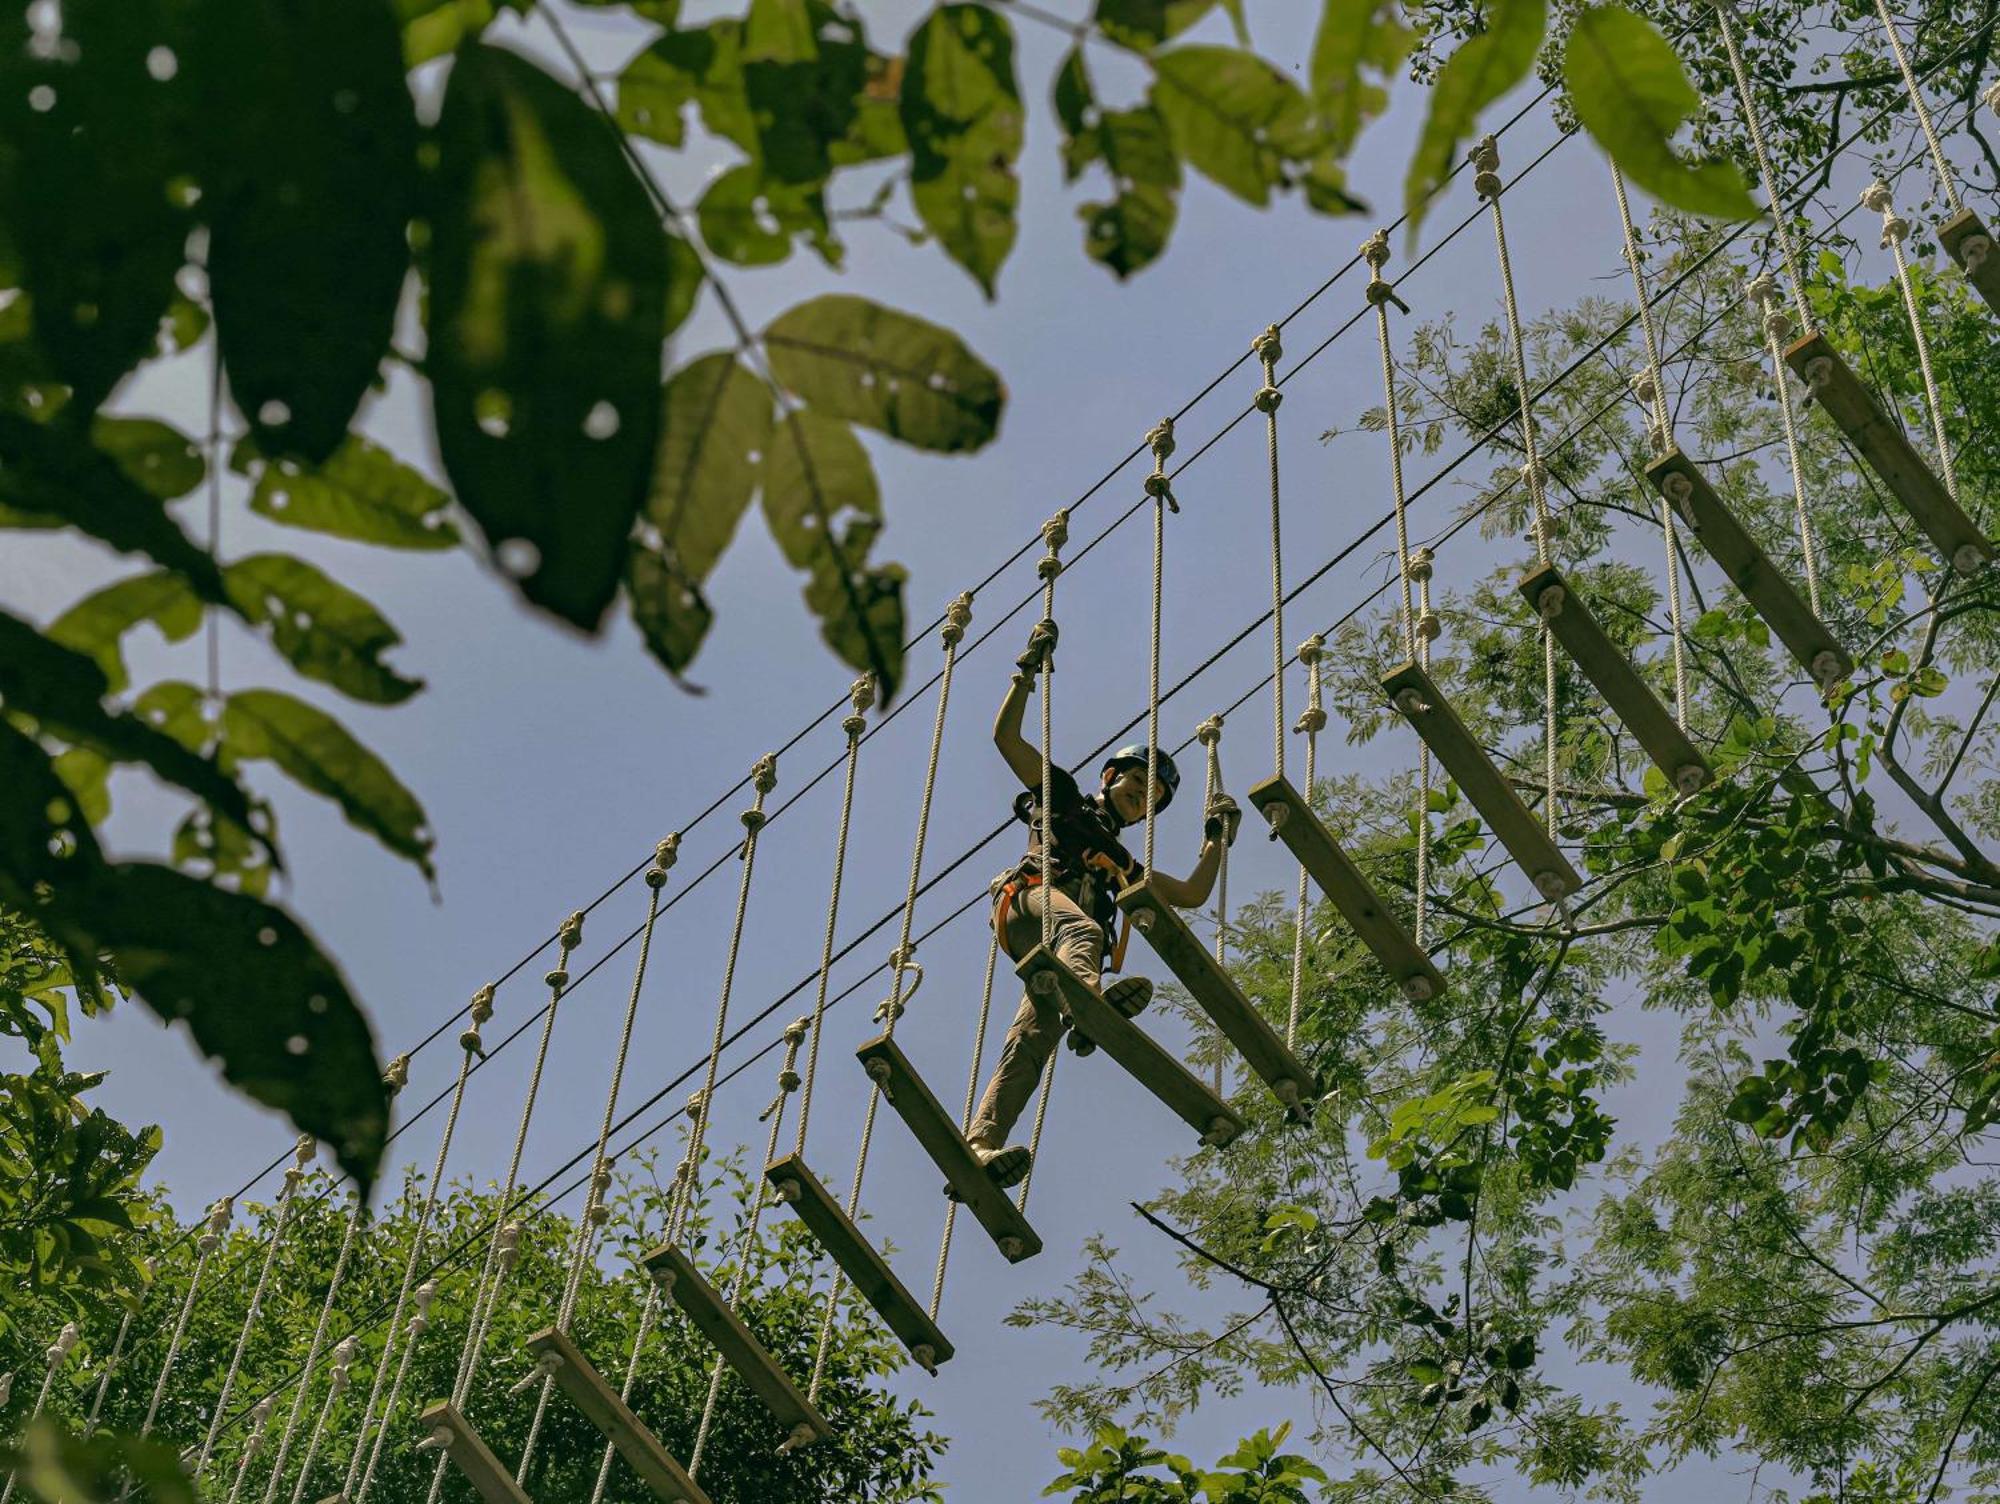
left=1562, top=4, right=1758, bottom=220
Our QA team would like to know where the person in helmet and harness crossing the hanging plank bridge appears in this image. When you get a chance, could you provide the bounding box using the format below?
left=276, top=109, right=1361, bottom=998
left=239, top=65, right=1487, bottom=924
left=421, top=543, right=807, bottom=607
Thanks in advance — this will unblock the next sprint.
left=966, top=622, right=1242, bottom=1188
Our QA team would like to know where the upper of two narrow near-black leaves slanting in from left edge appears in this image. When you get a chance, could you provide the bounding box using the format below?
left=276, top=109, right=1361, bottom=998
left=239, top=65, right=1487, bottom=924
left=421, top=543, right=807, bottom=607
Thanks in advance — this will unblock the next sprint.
left=0, top=414, right=224, bottom=602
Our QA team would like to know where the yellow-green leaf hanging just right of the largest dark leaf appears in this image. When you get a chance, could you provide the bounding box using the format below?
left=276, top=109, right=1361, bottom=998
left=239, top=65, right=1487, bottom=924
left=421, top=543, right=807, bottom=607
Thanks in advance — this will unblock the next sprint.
left=626, top=352, right=770, bottom=674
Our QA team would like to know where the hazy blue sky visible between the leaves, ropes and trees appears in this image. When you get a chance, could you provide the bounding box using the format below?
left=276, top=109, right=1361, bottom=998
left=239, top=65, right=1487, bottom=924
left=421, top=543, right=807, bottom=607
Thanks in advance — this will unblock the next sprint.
left=0, top=0, right=1960, bottom=1504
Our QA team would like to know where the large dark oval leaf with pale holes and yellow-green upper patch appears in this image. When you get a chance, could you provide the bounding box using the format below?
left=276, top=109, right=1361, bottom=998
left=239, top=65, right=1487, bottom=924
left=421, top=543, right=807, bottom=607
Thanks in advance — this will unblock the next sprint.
left=426, top=46, right=668, bottom=630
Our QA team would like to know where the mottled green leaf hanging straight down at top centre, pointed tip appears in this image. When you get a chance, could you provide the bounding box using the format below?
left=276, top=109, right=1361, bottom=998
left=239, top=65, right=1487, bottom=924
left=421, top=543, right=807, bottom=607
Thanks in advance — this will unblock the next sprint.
left=900, top=4, right=1022, bottom=298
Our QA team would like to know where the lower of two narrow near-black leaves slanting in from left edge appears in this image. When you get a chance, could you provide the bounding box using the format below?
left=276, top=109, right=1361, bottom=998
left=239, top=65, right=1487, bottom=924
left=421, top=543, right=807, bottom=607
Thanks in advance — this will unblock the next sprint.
left=0, top=612, right=250, bottom=826
